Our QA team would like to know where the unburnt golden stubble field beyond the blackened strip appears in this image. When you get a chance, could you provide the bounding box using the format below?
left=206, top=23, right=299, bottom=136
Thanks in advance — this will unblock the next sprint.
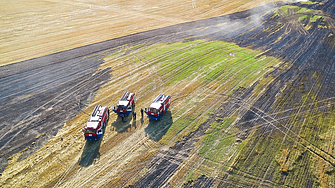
left=0, top=0, right=282, bottom=66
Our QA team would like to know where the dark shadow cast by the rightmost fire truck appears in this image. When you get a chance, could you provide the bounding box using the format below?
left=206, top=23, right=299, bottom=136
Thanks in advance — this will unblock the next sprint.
left=144, top=111, right=173, bottom=142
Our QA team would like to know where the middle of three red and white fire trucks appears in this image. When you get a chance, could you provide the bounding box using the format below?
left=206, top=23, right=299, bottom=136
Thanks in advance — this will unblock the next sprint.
left=113, top=91, right=135, bottom=116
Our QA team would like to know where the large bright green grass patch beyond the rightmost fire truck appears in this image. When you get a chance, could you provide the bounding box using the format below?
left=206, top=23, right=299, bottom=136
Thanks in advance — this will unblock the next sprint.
left=155, top=40, right=280, bottom=143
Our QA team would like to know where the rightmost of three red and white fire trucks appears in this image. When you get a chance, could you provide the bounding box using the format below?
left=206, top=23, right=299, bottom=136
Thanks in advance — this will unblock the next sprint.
left=144, top=94, right=171, bottom=120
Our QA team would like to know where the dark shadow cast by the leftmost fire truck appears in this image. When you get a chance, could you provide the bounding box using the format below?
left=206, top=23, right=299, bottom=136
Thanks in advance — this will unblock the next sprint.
left=79, top=127, right=106, bottom=167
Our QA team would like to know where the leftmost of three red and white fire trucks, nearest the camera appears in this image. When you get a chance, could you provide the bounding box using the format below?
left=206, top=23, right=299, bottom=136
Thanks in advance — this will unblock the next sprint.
left=84, top=105, right=109, bottom=140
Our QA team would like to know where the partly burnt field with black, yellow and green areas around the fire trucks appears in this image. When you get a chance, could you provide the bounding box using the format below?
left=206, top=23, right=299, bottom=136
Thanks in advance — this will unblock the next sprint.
left=0, top=1, right=335, bottom=187
